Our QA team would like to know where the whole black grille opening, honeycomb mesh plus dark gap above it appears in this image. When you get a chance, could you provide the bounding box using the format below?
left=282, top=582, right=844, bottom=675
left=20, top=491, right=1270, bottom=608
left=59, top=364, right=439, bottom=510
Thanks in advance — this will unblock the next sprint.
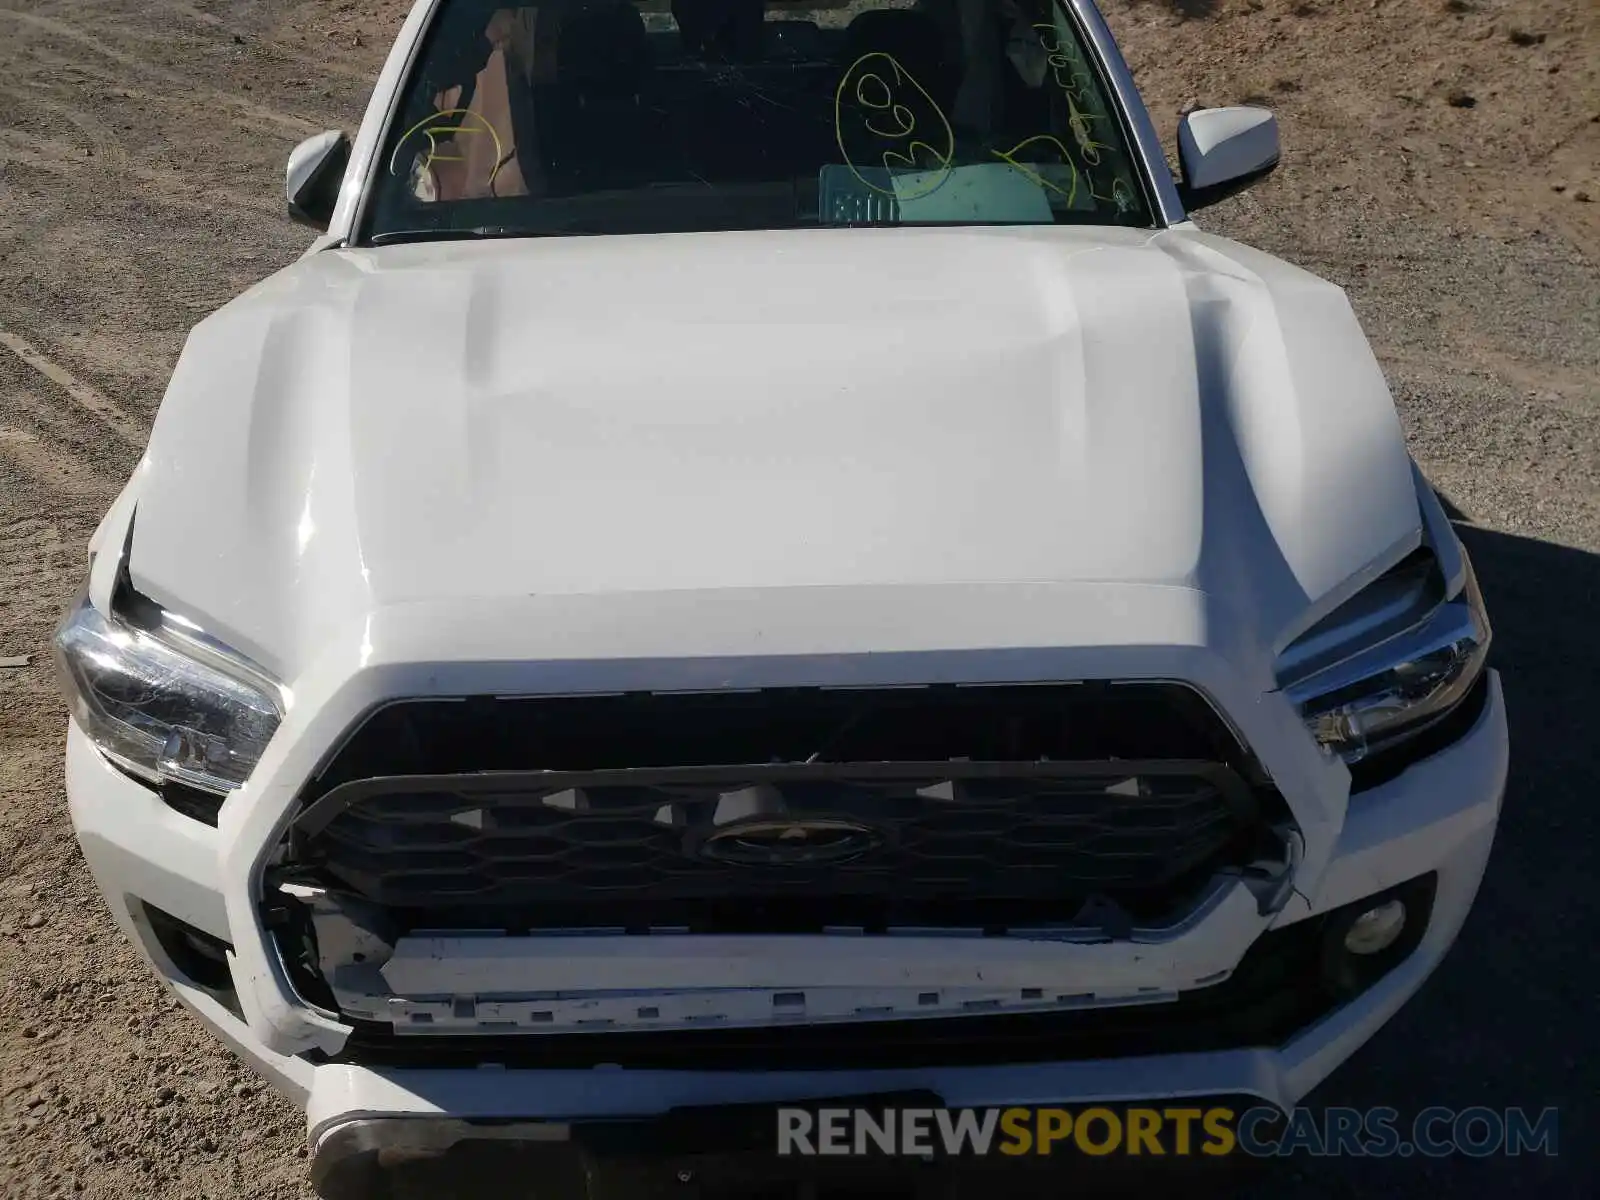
left=291, top=685, right=1261, bottom=933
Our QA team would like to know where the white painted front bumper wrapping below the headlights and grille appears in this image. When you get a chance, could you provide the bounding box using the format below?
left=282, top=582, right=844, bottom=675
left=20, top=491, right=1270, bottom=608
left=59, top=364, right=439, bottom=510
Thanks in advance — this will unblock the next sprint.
left=67, top=675, right=1507, bottom=1142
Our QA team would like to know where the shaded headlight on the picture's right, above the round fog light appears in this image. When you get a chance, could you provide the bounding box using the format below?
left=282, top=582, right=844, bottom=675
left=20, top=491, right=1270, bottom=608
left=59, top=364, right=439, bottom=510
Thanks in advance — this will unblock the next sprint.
left=1278, top=547, right=1491, bottom=763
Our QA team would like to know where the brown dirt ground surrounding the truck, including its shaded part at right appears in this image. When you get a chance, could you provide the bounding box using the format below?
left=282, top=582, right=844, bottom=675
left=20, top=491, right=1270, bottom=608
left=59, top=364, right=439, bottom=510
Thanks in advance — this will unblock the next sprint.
left=0, top=0, right=1600, bottom=1200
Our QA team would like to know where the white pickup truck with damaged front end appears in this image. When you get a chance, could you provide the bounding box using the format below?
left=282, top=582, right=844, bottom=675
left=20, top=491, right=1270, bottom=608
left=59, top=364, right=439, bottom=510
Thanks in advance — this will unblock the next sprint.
left=56, top=0, right=1507, bottom=1197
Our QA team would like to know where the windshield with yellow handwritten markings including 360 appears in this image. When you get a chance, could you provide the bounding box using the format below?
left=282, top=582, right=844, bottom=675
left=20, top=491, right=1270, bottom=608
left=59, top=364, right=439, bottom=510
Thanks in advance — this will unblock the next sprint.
left=365, top=0, right=1150, bottom=243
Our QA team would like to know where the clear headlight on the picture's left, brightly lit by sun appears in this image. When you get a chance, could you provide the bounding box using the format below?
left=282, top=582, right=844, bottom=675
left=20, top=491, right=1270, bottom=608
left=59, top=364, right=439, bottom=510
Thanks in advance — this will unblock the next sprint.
left=54, top=595, right=283, bottom=792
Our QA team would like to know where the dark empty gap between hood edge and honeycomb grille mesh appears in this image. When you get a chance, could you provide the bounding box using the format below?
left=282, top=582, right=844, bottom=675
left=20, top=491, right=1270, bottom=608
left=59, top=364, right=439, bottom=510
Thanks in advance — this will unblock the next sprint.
left=302, top=682, right=1262, bottom=803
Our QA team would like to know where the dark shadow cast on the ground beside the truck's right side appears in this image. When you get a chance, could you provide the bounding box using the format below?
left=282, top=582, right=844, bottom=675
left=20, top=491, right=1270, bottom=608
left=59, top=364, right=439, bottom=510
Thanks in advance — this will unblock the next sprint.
left=328, top=518, right=1600, bottom=1200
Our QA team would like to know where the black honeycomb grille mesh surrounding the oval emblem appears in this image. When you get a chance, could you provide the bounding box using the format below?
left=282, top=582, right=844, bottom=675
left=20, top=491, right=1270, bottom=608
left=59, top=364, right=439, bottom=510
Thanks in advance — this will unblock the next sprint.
left=294, top=765, right=1248, bottom=925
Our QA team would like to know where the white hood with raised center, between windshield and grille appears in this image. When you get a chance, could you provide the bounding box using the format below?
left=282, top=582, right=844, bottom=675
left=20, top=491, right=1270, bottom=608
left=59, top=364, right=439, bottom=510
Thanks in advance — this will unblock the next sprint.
left=131, top=229, right=1419, bottom=677
